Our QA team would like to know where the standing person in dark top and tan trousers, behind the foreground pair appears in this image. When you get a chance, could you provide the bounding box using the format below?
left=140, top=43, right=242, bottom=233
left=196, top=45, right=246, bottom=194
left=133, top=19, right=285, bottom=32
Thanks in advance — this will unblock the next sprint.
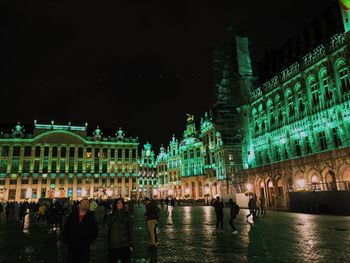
left=145, top=197, right=160, bottom=248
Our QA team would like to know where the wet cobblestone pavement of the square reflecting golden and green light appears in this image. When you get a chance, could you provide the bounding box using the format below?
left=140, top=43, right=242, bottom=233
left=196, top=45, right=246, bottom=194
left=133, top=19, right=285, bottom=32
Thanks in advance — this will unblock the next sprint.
left=0, top=207, right=350, bottom=263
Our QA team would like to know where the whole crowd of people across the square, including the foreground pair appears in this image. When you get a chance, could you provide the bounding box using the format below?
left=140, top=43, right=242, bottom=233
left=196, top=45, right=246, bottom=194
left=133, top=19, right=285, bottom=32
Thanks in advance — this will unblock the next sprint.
left=0, top=195, right=266, bottom=263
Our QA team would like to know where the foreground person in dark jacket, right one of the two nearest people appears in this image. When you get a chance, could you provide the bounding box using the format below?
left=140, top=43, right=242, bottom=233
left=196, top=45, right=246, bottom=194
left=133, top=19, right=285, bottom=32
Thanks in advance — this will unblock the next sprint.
left=105, top=199, right=134, bottom=263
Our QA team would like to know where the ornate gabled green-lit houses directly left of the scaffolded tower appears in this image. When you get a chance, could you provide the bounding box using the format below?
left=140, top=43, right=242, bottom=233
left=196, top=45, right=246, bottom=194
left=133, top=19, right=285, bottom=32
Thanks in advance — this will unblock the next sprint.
left=157, top=113, right=233, bottom=199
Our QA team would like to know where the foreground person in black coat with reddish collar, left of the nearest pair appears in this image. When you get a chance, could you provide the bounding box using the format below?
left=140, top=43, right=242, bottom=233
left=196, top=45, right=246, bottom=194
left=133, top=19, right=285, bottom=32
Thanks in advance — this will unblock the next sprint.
left=63, top=199, right=98, bottom=263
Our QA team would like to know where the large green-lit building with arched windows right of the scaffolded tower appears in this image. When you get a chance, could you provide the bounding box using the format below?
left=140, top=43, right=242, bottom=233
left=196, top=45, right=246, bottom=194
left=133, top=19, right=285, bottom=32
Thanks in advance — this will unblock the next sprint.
left=240, top=1, right=350, bottom=208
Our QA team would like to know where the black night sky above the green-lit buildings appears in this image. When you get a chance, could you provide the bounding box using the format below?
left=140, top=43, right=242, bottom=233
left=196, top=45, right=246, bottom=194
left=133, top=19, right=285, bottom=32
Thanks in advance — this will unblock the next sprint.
left=0, top=0, right=334, bottom=147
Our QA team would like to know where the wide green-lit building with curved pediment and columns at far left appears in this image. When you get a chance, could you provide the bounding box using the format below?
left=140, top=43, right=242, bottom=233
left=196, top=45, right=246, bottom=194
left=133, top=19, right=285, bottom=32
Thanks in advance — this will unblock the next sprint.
left=0, top=122, right=139, bottom=201
